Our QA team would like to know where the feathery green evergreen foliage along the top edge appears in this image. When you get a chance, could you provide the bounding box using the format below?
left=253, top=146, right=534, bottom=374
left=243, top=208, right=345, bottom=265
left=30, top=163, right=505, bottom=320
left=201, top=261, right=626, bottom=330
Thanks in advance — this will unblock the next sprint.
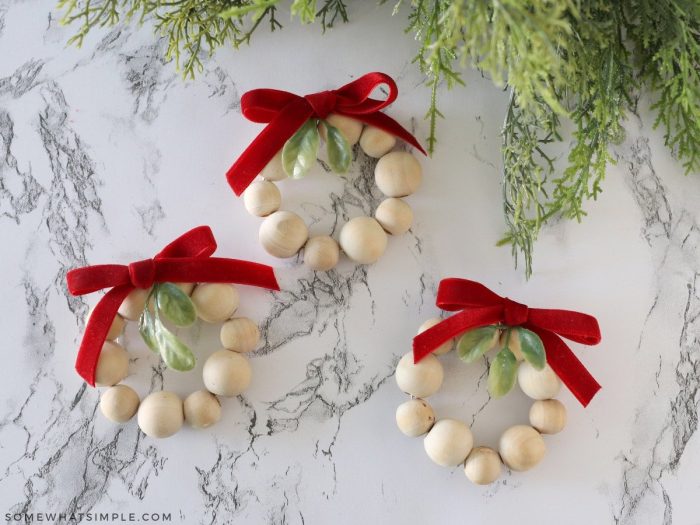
left=59, top=0, right=700, bottom=276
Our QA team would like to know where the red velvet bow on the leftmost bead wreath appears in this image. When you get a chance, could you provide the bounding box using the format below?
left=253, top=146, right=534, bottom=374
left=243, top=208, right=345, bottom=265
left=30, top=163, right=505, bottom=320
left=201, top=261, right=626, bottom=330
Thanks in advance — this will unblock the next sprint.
left=66, top=226, right=279, bottom=386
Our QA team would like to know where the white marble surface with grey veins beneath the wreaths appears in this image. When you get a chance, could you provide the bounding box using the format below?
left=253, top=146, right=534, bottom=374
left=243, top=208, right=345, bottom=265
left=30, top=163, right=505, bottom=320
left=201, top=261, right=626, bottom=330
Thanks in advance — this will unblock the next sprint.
left=0, top=0, right=700, bottom=524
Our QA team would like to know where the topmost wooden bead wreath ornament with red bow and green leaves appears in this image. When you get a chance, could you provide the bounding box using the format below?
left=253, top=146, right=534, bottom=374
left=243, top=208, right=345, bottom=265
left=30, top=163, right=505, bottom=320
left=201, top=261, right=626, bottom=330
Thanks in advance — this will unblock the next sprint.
left=226, top=73, right=425, bottom=271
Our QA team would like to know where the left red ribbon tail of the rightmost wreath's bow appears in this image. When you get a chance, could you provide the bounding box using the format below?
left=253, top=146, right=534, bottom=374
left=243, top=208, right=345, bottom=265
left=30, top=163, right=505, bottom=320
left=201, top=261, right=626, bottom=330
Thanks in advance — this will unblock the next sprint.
left=413, top=306, right=503, bottom=363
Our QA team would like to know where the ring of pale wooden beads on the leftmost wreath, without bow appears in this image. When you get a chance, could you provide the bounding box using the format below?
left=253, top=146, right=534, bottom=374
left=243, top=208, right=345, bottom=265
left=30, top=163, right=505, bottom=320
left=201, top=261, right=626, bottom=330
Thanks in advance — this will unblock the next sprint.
left=90, top=283, right=260, bottom=438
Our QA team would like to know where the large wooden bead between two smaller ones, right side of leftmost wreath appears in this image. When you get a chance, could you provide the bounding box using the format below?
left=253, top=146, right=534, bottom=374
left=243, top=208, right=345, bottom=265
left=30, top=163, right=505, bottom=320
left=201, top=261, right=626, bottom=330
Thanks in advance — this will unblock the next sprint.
left=202, top=350, right=253, bottom=397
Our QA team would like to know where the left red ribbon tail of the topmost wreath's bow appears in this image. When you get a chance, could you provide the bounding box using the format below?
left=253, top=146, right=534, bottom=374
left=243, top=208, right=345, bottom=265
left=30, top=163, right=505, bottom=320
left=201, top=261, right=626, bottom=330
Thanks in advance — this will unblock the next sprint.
left=226, top=99, right=313, bottom=196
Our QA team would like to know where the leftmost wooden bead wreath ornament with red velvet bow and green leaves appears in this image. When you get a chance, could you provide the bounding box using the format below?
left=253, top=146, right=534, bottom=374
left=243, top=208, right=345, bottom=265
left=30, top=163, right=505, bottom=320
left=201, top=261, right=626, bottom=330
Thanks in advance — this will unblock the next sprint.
left=67, top=226, right=279, bottom=438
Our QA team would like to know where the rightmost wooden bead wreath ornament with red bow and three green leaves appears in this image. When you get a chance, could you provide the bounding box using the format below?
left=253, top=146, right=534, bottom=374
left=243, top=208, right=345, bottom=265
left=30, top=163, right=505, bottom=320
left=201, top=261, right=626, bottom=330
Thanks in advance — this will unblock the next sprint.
left=396, top=279, right=600, bottom=485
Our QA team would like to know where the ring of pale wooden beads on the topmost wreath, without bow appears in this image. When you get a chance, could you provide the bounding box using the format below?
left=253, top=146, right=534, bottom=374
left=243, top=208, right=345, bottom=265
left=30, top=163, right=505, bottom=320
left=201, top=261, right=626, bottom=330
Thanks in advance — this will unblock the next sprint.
left=243, top=114, right=422, bottom=271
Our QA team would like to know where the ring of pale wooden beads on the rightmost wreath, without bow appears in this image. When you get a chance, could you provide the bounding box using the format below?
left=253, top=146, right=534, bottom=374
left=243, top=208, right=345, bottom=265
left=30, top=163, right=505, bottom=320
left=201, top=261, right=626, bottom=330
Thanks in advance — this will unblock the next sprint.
left=396, top=319, right=566, bottom=485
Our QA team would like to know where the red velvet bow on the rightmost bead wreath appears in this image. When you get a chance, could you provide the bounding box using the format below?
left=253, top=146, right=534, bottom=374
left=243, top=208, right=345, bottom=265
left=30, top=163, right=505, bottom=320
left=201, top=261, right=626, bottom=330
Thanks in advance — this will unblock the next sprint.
left=413, top=278, right=600, bottom=406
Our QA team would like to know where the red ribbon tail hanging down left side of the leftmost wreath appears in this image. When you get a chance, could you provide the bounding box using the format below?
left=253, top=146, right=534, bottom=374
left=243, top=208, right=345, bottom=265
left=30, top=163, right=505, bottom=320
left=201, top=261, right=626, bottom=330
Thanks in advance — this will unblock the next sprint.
left=75, top=285, right=133, bottom=386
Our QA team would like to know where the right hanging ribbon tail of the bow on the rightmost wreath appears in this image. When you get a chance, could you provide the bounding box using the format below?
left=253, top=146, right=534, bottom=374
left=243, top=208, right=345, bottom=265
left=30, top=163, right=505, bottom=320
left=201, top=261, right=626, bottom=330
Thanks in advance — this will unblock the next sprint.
left=526, top=325, right=601, bottom=407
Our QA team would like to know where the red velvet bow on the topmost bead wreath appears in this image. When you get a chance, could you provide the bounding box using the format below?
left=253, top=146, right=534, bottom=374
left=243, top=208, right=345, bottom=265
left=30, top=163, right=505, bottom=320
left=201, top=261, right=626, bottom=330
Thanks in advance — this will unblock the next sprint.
left=226, top=73, right=426, bottom=195
